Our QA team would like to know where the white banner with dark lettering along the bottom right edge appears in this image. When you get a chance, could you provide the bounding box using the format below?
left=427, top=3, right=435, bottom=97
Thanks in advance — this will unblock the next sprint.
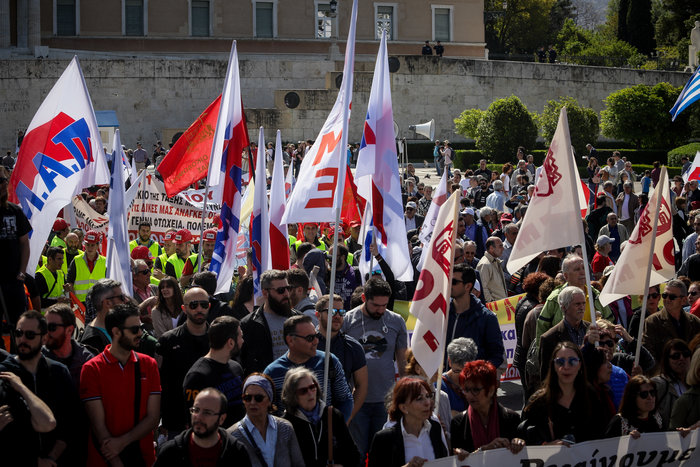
left=423, top=430, right=700, bottom=467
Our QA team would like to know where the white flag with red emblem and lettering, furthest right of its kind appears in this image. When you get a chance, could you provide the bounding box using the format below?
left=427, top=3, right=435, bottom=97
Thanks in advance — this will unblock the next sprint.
left=600, top=167, right=676, bottom=305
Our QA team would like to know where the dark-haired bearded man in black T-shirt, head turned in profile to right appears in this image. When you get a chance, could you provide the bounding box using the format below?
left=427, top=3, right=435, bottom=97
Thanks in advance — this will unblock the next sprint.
left=183, top=316, right=245, bottom=428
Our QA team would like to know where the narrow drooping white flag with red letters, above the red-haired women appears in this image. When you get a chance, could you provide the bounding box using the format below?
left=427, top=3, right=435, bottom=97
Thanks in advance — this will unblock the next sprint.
left=410, top=191, right=459, bottom=377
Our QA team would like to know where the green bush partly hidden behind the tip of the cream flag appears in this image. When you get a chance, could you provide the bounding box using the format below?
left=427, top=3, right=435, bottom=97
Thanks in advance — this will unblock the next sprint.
left=537, top=97, right=600, bottom=154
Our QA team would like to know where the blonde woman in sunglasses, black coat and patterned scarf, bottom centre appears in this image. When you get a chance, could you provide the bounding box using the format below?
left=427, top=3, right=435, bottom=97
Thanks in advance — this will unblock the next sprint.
left=282, top=367, right=360, bottom=467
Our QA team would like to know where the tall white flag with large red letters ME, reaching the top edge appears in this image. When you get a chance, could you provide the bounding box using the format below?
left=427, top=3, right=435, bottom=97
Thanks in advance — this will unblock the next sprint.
left=282, top=0, right=357, bottom=224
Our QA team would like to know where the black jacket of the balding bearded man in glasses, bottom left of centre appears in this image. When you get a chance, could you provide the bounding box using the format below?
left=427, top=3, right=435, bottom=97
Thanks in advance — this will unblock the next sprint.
left=153, top=428, right=251, bottom=467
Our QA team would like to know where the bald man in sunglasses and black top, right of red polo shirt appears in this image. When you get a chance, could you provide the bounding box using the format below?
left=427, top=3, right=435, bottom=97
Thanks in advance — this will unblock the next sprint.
left=158, top=287, right=209, bottom=439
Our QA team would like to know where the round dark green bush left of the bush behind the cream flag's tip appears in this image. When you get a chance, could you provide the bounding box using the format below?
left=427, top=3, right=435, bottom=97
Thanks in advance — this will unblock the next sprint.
left=475, top=96, right=537, bottom=163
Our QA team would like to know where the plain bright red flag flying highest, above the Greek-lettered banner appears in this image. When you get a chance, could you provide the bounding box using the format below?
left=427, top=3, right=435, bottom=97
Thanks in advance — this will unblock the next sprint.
left=158, top=96, right=221, bottom=196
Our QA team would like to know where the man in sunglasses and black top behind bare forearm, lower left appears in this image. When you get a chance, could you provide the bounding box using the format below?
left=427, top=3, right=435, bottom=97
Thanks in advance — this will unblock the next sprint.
left=0, top=310, right=79, bottom=466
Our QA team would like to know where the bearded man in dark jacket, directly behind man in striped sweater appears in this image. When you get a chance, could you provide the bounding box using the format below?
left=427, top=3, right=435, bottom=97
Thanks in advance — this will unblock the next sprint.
left=241, top=269, right=294, bottom=375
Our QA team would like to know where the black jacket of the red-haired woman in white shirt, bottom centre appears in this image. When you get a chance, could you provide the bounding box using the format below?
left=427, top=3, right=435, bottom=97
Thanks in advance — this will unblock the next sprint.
left=368, top=420, right=448, bottom=467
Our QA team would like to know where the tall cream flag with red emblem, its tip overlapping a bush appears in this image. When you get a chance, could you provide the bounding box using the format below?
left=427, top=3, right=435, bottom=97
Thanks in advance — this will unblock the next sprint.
left=507, top=107, right=585, bottom=274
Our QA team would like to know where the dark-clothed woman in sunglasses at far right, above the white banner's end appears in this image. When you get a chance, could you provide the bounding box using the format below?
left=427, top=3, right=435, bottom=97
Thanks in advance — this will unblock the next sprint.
left=651, top=339, right=691, bottom=430
